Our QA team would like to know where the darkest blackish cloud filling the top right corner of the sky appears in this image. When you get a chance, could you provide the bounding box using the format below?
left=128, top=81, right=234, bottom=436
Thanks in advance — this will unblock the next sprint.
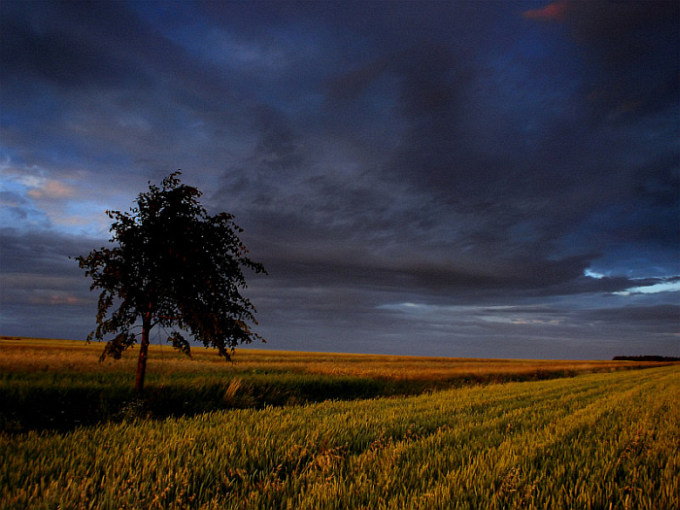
left=548, top=1, right=680, bottom=115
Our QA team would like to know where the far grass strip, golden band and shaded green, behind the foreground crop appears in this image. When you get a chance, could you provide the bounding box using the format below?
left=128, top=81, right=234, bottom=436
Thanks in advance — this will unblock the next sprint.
left=0, top=337, right=676, bottom=432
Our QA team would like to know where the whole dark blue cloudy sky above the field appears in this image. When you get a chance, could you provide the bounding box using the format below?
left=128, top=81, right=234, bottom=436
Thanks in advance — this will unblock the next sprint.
left=0, top=0, right=680, bottom=359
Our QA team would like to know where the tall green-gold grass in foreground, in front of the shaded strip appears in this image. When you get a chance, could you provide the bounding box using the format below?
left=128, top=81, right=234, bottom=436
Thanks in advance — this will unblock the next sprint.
left=0, top=366, right=680, bottom=510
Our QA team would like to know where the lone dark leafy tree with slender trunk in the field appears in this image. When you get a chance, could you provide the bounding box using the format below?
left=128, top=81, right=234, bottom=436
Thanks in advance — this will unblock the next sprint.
left=76, top=170, right=266, bottom=396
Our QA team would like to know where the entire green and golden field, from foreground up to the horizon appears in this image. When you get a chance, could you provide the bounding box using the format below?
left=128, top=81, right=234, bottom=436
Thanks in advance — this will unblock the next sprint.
left=0, top=340, right=680, bottom=509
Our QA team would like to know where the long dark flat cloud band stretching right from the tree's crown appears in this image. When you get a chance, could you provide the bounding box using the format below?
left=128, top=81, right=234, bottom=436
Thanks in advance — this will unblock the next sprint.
left=238, top=234, right=677, bottom=302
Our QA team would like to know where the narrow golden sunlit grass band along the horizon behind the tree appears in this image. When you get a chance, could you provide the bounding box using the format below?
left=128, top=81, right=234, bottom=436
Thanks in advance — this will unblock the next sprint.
left=0, top=337, right=663, bottom=380
